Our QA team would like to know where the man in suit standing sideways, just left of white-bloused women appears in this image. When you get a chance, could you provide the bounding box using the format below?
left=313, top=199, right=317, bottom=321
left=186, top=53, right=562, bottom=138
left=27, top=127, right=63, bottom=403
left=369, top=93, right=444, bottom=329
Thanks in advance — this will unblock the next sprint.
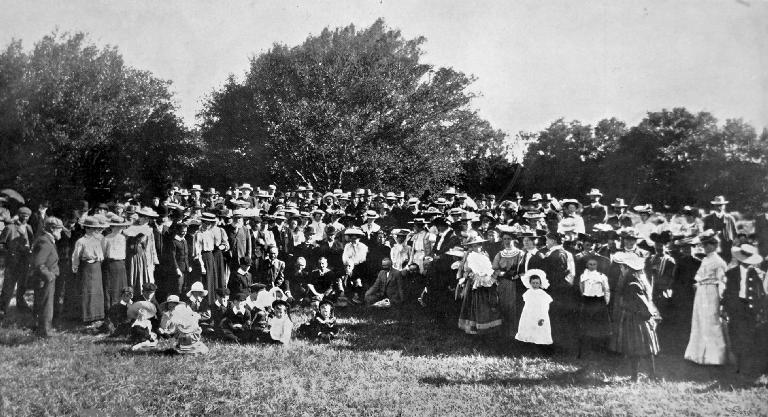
left=31, top=217, right=64, bottom=338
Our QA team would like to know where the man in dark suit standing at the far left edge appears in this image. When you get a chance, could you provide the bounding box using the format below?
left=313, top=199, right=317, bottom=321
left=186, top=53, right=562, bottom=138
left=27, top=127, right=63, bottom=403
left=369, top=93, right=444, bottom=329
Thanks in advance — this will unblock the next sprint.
left=0, top=207, right=35, bottom=316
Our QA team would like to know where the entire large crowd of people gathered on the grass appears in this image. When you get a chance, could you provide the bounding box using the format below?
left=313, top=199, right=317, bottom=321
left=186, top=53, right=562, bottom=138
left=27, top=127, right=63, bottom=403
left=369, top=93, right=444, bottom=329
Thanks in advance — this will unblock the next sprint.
left=0, top=184, right=768, bottom=378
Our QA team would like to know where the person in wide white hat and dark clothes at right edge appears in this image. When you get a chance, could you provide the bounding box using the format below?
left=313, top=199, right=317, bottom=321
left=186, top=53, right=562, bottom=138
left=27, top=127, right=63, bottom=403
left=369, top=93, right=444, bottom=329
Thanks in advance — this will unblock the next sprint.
left=722, top=244, right=768, bottom=375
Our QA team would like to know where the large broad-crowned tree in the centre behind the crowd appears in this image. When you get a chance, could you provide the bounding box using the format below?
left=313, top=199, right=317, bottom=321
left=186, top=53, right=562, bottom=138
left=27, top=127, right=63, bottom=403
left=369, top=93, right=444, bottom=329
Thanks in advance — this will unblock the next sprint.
left=201, top=20, right=506, bottom=191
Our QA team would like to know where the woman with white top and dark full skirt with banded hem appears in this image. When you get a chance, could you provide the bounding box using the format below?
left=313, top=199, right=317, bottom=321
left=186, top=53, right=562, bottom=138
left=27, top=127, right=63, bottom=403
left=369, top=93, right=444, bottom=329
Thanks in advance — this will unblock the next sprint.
left=459, top=236, right=502, bottom=334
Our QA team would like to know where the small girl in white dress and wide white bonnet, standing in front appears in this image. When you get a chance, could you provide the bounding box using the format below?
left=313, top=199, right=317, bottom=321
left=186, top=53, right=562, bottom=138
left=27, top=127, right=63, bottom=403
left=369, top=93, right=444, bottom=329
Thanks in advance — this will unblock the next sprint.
left=515, top=269, right=552, bottom=345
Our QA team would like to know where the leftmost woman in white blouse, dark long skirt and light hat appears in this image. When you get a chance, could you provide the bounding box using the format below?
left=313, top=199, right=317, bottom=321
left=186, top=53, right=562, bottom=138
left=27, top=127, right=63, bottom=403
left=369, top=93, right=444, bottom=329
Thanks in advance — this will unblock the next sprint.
left=72, top=216, right=106, bottom=327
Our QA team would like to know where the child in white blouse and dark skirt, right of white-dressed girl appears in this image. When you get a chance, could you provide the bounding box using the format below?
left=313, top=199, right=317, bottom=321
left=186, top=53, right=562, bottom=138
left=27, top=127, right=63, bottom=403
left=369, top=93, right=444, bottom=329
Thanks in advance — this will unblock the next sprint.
left=578, top=258, right=611, bottom=357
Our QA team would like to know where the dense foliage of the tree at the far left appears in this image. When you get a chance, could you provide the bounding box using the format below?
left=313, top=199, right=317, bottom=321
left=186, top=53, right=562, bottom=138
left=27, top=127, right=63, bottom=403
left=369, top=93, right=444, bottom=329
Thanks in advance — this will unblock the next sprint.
left=0, top=33, right=200, bottom=206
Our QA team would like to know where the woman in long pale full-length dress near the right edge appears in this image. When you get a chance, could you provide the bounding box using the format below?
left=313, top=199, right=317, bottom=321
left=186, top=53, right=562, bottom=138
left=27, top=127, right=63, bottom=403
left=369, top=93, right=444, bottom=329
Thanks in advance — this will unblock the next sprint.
left=685, top=233, right=728, bottom=365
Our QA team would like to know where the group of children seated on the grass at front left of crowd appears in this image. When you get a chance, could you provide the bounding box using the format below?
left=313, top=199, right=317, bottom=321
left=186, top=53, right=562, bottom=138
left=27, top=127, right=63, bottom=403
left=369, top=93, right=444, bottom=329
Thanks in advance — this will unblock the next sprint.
left=103, top=282, right=338, bottom=353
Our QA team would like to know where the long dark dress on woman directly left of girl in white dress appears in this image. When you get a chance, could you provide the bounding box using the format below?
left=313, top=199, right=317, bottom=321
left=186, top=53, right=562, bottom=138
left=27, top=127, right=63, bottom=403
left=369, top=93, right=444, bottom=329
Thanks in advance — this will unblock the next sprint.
left=493, top=248, right=522, bottom=337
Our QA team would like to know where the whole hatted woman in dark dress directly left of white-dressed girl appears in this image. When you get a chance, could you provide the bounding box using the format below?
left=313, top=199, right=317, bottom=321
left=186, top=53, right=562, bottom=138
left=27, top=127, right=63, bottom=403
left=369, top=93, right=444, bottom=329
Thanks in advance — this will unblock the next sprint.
left=493, top=226, right=523, bottom=337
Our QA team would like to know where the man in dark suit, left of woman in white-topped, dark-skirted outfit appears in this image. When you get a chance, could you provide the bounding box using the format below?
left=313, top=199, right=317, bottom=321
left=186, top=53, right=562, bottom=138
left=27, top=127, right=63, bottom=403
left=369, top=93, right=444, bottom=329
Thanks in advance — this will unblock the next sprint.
left=427, top=217, right=461, bottom=320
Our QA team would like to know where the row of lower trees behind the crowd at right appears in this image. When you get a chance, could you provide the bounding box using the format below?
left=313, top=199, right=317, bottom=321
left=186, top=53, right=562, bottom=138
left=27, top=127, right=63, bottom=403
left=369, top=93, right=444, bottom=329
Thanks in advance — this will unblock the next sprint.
left=524, top=108, right=768, bottom=210
